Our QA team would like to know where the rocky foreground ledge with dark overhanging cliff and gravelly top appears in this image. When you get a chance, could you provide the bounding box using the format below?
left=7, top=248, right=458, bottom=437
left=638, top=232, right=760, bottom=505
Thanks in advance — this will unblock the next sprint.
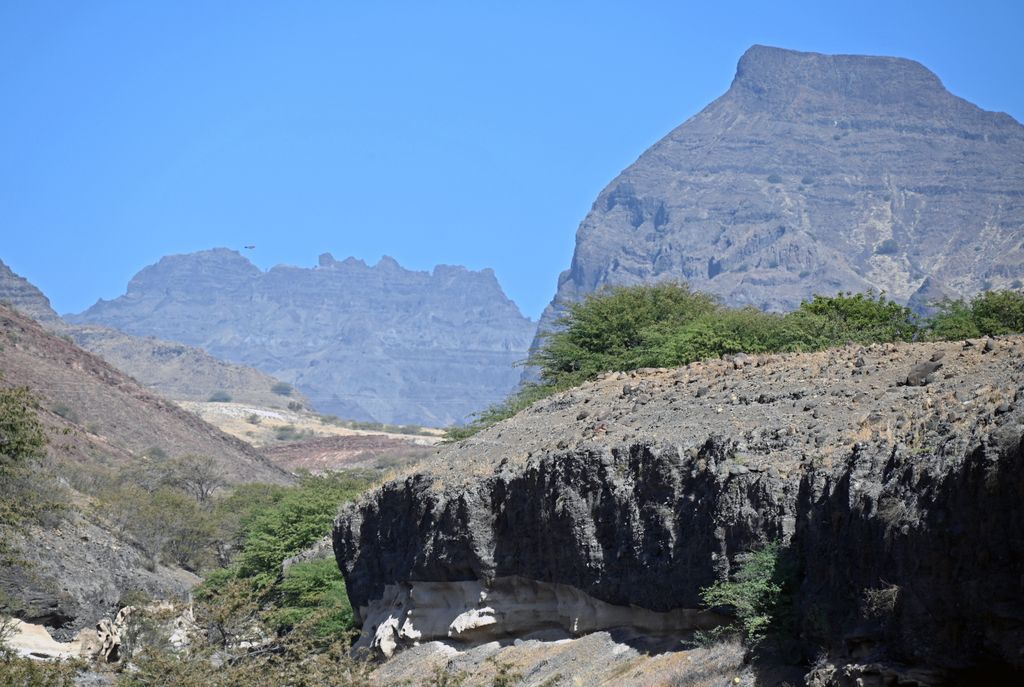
left=334, top=338, right=1024, bottom=684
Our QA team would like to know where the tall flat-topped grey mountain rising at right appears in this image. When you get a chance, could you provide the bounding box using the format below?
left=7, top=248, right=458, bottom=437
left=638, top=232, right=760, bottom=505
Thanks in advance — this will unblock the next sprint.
left=541, top=45, right=1024, bottom=339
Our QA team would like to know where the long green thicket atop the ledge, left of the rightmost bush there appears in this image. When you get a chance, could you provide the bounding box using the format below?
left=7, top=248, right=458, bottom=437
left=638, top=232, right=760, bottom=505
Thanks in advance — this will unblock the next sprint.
left=446, top=283, right=921, bottom=440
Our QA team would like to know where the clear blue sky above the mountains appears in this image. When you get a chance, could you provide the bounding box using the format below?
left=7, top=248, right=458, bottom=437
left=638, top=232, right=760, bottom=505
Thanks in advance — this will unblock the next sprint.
left=0, top=0, right=1024, bottom=317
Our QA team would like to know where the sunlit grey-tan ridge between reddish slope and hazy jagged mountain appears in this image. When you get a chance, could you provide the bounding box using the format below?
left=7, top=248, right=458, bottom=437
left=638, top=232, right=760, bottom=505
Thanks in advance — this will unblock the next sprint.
left=0, top=260, right=308, bottom=407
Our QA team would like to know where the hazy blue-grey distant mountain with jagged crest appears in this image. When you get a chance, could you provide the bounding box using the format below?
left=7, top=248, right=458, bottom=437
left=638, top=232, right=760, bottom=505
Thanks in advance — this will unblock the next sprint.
left=69, top=249, right=535, bottom=426
